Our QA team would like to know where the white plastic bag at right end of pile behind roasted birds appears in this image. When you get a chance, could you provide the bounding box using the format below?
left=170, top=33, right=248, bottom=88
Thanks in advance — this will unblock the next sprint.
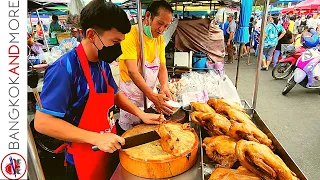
left=219, top=75, right=241, bottom=104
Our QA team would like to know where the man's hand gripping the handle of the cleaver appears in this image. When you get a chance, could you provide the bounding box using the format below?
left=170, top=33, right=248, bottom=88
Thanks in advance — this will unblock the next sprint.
left=93, top=133, right=125, bottom=153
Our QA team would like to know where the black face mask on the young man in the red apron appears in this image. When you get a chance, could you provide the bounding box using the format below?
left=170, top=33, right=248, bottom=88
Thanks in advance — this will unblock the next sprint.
left=93, top=34, right=122, bottom=63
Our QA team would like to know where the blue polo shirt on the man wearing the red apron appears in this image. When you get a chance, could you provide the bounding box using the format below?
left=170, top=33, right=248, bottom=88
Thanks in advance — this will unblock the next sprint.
left=37, top=49, right=118, bottom=164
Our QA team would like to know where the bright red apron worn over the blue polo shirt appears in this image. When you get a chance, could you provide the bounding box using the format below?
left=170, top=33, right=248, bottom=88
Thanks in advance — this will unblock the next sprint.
left=68, top=44, right=116, bottom=180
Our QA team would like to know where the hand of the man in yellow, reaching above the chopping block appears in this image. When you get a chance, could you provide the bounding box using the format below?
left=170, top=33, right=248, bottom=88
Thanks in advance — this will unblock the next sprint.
left=148, top=93, right=173, bottom=115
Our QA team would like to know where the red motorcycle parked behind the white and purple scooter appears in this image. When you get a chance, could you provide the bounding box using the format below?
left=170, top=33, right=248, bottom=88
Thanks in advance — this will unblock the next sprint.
left=272, top=45, right=307, bottom=80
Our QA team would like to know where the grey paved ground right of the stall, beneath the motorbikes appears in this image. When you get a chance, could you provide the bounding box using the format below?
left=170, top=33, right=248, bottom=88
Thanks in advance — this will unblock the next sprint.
left=225, top=57, right=320, bottom=180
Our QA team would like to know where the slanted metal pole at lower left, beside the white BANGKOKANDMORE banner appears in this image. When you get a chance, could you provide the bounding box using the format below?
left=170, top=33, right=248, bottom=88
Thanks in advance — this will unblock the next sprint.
left=27, top=123, right=45, bottom=180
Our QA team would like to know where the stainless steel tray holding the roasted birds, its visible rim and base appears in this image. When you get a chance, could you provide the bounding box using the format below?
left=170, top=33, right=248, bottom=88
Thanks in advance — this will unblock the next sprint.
left=201, top=100, right=307, bottom=180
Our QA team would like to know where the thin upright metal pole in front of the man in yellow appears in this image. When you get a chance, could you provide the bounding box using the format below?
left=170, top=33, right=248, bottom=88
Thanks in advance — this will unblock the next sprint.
left=136, top=0, right=148, bottom=110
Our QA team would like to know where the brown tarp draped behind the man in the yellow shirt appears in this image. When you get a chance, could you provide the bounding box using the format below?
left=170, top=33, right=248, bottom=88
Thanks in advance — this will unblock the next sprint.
left=175, top=18, right=225, bottom=62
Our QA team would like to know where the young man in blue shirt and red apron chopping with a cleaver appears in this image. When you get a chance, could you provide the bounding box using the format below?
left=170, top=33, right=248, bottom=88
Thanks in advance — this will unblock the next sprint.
left=35, top=0, right=159, bottom=180
